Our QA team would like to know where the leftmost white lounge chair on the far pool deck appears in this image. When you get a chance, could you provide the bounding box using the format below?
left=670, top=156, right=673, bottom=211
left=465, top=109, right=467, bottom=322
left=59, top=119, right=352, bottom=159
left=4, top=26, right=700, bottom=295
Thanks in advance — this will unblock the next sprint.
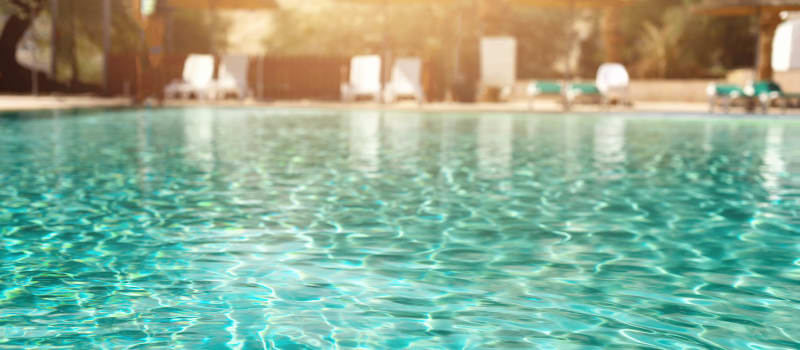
left=164, top=54, right=214, bottom=98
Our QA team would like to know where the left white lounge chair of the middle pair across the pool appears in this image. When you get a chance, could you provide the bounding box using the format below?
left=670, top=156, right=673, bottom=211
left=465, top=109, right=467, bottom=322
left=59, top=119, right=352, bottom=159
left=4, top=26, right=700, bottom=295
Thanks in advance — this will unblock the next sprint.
left=341, top=55, right=383, bottom=102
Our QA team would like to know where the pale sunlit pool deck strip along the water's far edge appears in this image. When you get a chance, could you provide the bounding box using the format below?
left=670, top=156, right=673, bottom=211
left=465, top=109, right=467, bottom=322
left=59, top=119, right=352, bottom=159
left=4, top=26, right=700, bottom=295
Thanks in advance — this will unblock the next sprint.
left=0, top=95, right=800, bottom=116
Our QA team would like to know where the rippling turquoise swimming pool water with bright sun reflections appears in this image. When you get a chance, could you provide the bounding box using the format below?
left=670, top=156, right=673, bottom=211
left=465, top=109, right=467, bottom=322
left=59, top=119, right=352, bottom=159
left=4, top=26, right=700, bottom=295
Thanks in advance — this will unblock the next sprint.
left=0, top=109, right=800, bottom=350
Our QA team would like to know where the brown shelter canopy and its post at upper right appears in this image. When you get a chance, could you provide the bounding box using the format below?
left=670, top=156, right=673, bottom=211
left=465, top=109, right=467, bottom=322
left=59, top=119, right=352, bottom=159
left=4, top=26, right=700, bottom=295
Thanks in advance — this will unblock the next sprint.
left=695, top=0, right=800, bottom=80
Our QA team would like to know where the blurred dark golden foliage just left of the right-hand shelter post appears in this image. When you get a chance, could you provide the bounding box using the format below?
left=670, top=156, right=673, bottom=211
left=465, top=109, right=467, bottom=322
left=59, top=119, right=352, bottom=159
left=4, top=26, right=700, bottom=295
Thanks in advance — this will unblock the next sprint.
left=622, top=0, right=756, bottom=78
